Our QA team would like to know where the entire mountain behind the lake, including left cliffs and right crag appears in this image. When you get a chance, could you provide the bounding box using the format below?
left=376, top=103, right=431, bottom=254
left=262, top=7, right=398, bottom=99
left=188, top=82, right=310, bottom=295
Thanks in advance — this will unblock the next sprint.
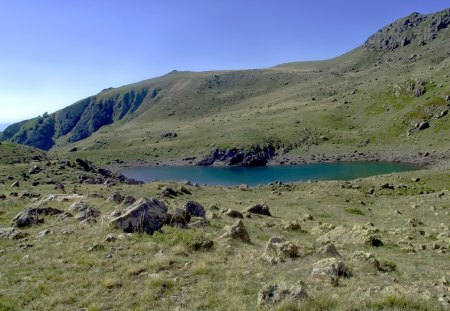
left=0, top=9, right=450, bottom=163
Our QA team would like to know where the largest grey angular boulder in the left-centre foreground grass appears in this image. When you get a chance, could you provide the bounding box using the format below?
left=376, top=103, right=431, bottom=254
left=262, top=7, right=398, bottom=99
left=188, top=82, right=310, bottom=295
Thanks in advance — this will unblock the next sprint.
left=110, top=198, right=168, bottom=234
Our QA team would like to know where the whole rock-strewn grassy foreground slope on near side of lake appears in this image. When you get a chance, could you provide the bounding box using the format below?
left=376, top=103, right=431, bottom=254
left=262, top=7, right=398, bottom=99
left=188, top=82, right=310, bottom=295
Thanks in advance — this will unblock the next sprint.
left=0, top=143, right=450, bottom=311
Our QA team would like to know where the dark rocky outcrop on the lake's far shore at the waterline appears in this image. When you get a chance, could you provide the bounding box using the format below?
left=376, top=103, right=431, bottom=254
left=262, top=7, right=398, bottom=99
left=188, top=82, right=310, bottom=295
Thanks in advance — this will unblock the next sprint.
left=197, top=145, right=275, bottom=167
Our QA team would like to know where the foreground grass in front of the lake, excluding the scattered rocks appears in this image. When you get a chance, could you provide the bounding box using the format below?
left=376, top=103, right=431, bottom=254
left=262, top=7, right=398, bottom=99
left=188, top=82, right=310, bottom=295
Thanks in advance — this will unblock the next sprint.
left=0, top=145, right=450, bottom=310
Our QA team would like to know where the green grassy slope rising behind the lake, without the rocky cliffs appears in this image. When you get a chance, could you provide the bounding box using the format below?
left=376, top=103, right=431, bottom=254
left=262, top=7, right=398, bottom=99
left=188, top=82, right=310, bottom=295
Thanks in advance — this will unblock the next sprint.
left=48, top=32, right=450, bottom=163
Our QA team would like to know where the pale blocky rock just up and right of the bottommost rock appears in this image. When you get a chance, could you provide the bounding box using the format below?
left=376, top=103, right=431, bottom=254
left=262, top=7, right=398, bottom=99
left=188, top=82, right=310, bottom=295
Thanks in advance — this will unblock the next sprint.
left=311, top=257, right=345, bottom=286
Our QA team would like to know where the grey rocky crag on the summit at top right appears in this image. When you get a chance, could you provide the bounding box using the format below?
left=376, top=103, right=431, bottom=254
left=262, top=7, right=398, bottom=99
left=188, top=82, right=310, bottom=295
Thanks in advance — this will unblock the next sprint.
left=364, top=9, right=450, bottom=52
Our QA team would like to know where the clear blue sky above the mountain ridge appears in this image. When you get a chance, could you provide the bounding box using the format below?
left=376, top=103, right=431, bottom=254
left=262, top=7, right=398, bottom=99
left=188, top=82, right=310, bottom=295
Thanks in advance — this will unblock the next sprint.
left=0, top=0, right=450, bottom=123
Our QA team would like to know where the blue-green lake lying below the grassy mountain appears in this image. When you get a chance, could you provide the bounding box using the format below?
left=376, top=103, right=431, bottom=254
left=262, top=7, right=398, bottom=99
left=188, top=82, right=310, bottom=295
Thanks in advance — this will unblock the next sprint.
left=122, top=162, right=420, bottom=186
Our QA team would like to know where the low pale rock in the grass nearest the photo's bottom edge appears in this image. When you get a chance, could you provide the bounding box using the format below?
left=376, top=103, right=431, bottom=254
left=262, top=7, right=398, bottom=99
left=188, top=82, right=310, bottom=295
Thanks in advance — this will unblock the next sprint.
left=258, top=283, right=309, bottom=305
